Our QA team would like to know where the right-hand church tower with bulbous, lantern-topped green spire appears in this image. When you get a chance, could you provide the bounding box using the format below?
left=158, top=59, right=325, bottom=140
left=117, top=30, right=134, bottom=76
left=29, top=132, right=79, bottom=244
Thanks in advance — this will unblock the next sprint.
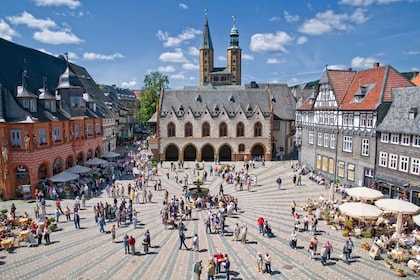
left=227, top=17, right=242, bottom=86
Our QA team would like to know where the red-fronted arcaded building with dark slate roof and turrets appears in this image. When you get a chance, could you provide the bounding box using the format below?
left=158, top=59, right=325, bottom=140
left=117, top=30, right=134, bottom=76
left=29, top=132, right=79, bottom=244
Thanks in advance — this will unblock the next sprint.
left=0, top=39, right=116, bottom=199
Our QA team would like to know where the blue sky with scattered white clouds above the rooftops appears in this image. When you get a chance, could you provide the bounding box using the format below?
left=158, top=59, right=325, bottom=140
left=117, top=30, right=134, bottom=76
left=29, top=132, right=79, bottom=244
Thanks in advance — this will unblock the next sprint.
left=0, top=0, right=420, bottom=89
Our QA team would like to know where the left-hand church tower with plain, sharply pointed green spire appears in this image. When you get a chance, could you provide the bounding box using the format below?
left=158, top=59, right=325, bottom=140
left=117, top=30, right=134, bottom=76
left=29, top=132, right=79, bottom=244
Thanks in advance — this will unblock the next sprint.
left=200, top=13, right=214, bottom=86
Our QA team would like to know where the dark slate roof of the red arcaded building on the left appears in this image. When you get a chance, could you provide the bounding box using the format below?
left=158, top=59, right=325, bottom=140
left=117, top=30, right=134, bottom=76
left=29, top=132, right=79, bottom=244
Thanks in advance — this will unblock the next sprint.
left=0, top=38, right=113, bottom=122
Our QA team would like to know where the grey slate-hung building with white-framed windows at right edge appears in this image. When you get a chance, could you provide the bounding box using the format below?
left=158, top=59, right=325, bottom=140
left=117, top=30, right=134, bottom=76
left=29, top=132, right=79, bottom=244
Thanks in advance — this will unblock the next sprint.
left=376, top=87, right=420, bottom=205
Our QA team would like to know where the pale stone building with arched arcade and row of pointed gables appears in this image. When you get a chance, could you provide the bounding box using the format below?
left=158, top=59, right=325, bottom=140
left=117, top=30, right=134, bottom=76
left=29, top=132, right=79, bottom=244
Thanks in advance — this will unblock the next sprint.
left=157, top=82, right=295, bottom=161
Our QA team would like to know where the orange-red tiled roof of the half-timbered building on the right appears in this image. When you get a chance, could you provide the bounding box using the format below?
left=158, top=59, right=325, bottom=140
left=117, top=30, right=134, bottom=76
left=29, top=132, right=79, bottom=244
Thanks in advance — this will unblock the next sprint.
left=340, top=65, right=413, bottom=111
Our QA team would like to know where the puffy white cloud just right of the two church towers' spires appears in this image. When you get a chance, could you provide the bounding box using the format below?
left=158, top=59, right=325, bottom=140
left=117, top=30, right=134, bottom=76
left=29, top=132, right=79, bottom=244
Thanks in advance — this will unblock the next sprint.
left=249, top=31, right=293, bottom=52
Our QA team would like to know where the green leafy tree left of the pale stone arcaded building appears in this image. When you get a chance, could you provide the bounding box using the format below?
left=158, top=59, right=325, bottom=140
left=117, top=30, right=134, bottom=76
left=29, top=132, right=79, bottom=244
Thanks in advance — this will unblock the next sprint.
left=135, top=72, right=169, bottom=123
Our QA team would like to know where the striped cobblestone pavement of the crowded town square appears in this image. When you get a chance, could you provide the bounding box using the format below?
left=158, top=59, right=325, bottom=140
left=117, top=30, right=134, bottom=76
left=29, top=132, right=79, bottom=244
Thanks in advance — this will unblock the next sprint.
left=0, top=158, right=416, bottom=280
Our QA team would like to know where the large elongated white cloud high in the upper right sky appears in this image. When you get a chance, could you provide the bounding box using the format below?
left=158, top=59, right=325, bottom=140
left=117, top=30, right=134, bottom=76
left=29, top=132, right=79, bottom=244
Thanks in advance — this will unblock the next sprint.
left=299, top=9, right=368, bottom=35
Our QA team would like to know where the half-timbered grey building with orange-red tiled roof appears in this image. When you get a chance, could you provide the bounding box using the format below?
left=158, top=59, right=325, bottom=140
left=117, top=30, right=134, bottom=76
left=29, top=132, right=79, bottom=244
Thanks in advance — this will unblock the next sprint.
left=296, top=63, right=413, bottom=189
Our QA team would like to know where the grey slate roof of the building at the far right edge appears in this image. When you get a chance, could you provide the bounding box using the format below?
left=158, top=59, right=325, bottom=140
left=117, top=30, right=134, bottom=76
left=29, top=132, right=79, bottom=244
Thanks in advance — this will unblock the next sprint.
left=377, top=87, right=420, bottom=135
